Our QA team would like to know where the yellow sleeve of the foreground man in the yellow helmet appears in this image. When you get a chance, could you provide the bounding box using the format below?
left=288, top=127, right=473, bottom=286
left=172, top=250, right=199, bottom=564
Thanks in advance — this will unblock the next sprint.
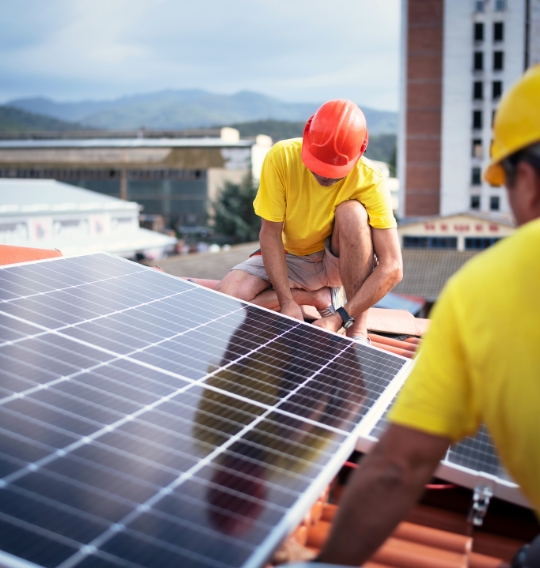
left=389, top=281, right=480, bottom=441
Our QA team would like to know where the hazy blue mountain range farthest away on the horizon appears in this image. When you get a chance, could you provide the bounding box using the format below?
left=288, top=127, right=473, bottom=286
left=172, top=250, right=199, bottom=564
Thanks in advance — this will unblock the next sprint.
left=7, top=89, right=397, bottom=134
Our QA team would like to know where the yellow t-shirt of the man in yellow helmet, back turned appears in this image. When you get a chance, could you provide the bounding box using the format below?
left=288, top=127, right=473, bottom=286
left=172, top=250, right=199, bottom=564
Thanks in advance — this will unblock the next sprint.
left=390, top=220, right=540, bottom=514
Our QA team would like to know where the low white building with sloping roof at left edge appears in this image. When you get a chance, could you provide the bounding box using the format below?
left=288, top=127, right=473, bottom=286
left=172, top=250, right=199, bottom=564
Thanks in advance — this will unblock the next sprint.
left=0, top=179, right=176, bottom=259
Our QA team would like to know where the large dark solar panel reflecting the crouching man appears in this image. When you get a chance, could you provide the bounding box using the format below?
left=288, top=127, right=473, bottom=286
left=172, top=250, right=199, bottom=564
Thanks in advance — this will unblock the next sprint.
left=0, top=254, right=409, bottom=568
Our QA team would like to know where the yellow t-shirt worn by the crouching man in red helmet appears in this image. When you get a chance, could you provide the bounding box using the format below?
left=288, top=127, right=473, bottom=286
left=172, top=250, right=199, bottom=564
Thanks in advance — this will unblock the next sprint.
left=253, top=138, right=396, bottom=256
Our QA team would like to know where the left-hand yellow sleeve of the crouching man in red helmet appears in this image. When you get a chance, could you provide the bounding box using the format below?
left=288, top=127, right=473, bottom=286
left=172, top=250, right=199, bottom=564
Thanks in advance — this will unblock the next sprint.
left=253, top=154, right=287, bottom=223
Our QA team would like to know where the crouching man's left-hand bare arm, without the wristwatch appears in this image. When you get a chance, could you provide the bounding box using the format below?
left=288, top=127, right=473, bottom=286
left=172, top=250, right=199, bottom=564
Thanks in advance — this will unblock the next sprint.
left=259, top=219, right=304, bottom=320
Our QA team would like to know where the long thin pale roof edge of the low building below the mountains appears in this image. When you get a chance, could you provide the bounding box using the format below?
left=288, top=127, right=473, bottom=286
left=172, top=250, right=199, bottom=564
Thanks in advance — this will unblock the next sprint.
left=0, top=138, right=254, bottom=150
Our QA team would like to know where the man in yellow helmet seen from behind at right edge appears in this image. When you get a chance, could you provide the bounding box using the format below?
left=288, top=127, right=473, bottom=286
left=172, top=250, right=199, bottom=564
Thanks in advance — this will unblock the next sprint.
left=317, top=66, right=540, bottom=568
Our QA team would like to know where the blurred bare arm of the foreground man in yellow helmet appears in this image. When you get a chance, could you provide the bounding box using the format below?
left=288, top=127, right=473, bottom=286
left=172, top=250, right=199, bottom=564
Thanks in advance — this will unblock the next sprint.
left=320, top=424, right=451, bottom=566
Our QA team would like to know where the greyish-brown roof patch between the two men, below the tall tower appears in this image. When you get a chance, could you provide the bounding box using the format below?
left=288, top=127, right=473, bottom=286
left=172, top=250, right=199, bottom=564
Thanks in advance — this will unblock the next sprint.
left=392, top=249, right=478, bottom=300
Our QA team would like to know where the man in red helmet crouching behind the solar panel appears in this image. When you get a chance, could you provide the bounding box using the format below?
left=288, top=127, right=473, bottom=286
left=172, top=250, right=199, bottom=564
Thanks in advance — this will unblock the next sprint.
left=217, top=100, right=402, bottom=343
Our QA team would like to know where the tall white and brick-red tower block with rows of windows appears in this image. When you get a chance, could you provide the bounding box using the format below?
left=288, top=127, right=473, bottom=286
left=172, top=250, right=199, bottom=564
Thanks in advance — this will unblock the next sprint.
left=398, top=0, right=540, bottom=217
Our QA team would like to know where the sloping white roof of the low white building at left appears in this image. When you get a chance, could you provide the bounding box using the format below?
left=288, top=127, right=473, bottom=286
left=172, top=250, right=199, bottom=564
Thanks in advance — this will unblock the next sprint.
left=0, top=179, right=138, bottom=216
